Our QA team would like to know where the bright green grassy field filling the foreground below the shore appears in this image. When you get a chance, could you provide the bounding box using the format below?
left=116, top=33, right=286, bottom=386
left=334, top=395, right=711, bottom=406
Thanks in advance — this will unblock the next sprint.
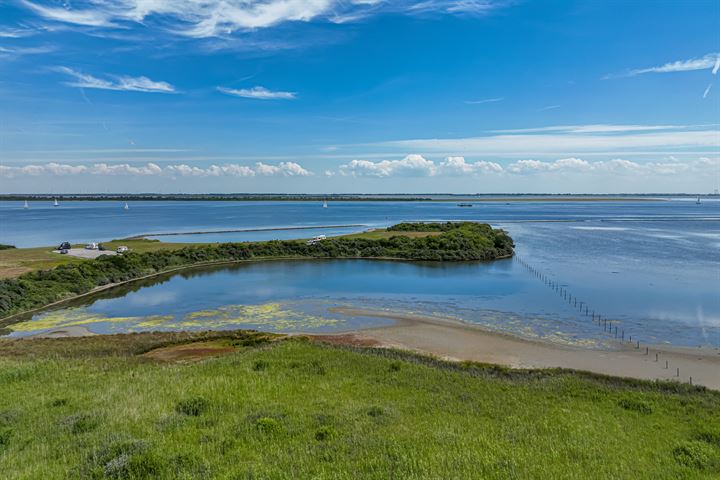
left=0, top=333, right=720, bottom=479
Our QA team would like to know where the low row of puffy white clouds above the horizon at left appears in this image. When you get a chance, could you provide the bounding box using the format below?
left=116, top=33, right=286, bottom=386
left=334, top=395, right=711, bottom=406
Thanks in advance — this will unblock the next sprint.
left=0, top=162, right=312, bottom=178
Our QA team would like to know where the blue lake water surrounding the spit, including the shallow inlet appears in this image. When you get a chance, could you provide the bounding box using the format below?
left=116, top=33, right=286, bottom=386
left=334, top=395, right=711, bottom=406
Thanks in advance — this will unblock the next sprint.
left=0, top=199, right=720, bottom=347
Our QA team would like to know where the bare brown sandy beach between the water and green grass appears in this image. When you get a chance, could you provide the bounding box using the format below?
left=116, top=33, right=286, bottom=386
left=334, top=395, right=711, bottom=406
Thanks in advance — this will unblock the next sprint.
left=323, top=309, right=720, bottom=390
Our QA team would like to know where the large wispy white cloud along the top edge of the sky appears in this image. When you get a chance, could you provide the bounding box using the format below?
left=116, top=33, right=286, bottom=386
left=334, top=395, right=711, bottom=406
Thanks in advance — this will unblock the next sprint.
left=21, top=0, right=498, bottom=38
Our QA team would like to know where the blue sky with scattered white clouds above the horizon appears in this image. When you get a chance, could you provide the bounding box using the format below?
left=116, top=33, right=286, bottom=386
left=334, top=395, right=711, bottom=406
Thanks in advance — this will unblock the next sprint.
left=0, top=0, right=720, bottom=193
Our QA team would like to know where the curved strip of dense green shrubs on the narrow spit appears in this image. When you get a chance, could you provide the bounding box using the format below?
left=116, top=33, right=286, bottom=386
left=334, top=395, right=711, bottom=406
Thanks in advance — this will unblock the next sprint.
left=0, top=222, right=514, bottom=318
